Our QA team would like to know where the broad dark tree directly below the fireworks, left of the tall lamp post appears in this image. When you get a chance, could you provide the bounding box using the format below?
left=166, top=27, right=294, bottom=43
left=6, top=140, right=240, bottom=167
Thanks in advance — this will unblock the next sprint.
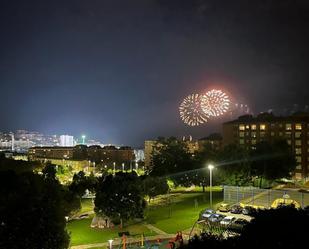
left=150, top=137, right=194, bottom=176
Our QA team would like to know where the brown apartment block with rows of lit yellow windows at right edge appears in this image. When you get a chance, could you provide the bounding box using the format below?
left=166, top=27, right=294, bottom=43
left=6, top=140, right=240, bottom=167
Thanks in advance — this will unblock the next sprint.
left=223, top=113, right=309, bottom=179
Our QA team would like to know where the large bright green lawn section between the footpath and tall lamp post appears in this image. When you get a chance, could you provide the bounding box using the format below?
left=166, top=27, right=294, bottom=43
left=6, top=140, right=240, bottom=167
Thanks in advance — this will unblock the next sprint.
left=146, top=188, right=223, bottom=234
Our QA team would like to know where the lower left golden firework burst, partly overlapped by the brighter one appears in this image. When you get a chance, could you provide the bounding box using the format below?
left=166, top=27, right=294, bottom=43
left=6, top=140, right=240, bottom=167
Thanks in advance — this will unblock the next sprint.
left=179, top=94, right=208, bottom=126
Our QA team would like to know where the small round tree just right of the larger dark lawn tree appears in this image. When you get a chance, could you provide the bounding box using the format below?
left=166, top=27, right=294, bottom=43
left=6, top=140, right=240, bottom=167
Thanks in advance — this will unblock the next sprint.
left=143, top=176, right=169, bottom=202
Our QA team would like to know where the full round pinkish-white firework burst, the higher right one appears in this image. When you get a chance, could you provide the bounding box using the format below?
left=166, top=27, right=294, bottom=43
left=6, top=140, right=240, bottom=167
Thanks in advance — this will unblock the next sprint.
left=201, top=89, right=230, bottom=117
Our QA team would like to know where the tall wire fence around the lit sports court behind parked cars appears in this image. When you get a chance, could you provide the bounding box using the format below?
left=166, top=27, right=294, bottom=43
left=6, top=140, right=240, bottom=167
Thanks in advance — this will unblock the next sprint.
left=223, top=186, right=309, bottom=208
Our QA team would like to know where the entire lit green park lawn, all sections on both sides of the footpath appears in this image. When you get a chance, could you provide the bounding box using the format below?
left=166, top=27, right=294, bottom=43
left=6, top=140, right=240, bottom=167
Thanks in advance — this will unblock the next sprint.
left=67, top=188, right=223, bottom=245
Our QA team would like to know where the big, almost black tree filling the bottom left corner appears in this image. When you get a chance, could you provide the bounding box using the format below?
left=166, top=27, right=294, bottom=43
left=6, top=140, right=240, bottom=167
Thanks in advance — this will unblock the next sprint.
left=0, top=171, right=69, bottom=249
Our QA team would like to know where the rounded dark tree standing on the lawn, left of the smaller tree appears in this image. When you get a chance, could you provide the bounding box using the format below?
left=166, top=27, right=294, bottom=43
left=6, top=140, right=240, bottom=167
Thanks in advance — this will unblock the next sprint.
left=94, top=172, right=145, bottom=227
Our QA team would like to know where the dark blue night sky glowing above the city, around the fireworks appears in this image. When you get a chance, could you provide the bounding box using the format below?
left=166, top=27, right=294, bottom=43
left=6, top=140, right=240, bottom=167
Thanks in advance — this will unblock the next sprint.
left=0, top=0, right=309, bottom=146
